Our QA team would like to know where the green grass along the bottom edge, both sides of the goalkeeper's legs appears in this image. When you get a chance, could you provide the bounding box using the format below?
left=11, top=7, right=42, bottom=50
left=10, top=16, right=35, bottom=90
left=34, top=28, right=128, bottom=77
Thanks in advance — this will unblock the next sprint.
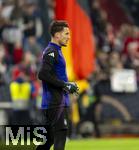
left=0, top=138, right=139, bottom=150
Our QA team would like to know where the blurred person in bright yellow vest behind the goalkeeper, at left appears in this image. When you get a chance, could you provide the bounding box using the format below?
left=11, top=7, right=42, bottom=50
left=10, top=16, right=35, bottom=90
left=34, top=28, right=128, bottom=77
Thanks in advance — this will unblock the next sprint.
left=10, top=71, right=32, bottom=125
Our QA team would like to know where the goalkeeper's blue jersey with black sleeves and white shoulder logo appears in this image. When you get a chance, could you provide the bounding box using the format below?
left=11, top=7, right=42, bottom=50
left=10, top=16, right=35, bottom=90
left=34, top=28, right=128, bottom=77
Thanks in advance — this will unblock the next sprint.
left=38, top=42, right=69, bottom=109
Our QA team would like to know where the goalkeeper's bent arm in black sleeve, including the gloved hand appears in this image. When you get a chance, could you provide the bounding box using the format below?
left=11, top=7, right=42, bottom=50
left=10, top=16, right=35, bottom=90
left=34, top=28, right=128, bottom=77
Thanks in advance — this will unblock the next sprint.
left=38, top=51, right=79, bottom=94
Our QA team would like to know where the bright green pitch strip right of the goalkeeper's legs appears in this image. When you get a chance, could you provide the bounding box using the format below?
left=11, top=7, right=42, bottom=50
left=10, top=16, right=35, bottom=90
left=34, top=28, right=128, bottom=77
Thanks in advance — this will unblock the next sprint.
left=66, top=138, right=139, bottom=150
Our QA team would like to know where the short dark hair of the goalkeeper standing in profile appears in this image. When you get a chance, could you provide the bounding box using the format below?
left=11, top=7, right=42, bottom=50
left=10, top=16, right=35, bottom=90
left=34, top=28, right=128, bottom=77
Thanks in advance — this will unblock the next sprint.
left=49, top=20, right=69, bottom=36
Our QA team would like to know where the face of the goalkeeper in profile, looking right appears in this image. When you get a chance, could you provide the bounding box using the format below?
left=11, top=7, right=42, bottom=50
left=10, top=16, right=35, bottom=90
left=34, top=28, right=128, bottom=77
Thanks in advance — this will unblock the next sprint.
left=59, top=27, right=70, bottom=46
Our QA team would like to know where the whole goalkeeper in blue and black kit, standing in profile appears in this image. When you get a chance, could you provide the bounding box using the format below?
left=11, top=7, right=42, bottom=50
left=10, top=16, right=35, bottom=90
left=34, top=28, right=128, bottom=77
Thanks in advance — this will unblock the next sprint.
left=37, top=21, right=78, bottom=150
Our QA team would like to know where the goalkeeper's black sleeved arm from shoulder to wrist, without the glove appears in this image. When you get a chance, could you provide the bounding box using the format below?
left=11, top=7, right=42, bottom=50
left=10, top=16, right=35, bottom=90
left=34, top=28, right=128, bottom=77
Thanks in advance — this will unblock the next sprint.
left=38, top=50, right=65, bottom=88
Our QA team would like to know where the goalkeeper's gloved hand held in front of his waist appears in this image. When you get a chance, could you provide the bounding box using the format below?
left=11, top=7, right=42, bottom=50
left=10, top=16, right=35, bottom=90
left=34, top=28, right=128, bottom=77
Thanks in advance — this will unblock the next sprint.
left=64, top=82, right=79, bottom=94
